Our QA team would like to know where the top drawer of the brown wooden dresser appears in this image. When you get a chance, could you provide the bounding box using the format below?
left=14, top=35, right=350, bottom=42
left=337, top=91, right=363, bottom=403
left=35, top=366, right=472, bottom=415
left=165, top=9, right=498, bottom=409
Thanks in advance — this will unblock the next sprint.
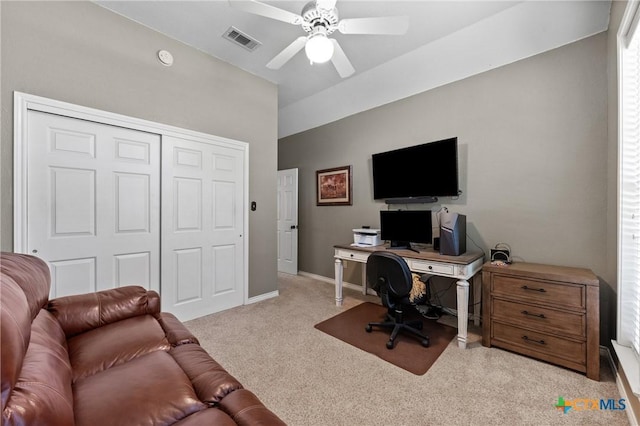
left=491, top=274, right=585, bottom=309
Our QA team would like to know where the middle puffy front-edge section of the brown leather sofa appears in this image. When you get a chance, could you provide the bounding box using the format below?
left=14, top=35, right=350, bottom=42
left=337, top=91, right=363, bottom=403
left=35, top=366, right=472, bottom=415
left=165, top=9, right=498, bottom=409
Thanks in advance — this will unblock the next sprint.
left=169, top=344, right=242, bottom=404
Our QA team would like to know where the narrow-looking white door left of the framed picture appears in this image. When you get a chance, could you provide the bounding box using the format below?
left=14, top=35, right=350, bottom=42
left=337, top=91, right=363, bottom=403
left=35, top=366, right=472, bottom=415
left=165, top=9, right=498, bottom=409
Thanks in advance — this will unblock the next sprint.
left=278, top=169, right=298, bottom=274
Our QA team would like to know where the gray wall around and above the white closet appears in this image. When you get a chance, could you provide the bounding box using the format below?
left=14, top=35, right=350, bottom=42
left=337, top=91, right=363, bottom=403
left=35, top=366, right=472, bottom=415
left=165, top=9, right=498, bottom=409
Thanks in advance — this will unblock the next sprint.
left=0, top=2, right=278, bottom=297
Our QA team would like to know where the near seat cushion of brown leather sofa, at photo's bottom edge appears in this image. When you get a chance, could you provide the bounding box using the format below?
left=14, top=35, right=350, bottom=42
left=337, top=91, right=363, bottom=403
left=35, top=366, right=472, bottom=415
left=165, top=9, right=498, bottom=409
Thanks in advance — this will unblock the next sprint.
left=73, top=351, right=207, bottom=426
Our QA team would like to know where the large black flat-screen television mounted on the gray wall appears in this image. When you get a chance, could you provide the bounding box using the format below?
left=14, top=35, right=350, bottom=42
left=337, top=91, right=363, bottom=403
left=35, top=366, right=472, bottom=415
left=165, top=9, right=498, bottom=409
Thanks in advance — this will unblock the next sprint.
left=371, top=138, right=460, bottom=202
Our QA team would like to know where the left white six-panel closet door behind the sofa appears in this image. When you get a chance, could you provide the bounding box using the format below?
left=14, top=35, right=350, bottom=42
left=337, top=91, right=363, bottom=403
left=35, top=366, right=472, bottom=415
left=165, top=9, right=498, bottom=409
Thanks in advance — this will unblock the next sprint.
left=26, top=111, right=160, bottom=297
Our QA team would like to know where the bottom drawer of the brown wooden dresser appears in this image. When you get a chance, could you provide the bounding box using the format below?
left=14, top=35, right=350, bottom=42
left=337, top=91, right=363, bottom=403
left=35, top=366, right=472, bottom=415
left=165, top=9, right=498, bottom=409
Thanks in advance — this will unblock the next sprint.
left=492, top=321, right=586, bottom=365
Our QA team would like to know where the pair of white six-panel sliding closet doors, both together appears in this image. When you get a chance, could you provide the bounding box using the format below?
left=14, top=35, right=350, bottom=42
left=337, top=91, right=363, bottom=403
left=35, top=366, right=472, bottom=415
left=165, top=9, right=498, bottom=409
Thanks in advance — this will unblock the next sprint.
left=21, top=106, right=246, bottom=321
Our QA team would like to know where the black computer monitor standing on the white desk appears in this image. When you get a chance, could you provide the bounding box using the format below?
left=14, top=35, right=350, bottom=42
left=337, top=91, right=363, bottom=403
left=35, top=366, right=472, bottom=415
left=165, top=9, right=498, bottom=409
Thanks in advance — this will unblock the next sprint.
left=380, top=210, right=432, bottom=250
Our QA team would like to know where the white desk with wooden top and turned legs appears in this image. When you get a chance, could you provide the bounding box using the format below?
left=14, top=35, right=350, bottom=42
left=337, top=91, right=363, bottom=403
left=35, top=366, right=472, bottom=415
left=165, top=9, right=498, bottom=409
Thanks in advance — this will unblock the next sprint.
left=333, top=244, right=484, bottom=349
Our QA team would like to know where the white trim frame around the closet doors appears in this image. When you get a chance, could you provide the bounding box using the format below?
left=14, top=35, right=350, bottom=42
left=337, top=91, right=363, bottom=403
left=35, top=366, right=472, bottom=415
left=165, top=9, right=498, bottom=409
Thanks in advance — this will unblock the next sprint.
left=13, top=92, right=249, bottom=305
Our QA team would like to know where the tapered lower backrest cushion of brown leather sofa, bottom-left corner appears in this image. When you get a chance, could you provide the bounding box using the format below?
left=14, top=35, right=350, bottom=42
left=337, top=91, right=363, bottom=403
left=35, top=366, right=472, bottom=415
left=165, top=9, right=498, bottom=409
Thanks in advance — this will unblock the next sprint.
left=2, top=310, right=74, bottom=426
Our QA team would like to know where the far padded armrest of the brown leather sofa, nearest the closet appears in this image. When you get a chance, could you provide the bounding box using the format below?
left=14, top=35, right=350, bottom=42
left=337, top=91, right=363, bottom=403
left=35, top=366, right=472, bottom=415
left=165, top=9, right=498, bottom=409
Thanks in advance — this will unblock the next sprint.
left=47, top=286, right=160, bottom=338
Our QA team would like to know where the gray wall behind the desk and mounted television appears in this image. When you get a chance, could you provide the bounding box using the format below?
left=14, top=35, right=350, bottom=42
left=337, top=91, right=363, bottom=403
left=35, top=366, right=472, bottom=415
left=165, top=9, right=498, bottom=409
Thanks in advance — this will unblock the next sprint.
left=278, top=33, right=613, bottom=292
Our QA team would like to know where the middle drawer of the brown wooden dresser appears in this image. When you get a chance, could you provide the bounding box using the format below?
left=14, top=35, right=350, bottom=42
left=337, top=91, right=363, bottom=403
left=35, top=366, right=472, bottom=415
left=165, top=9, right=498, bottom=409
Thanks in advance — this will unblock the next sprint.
left=491, top=298, right=586, bottom=338
